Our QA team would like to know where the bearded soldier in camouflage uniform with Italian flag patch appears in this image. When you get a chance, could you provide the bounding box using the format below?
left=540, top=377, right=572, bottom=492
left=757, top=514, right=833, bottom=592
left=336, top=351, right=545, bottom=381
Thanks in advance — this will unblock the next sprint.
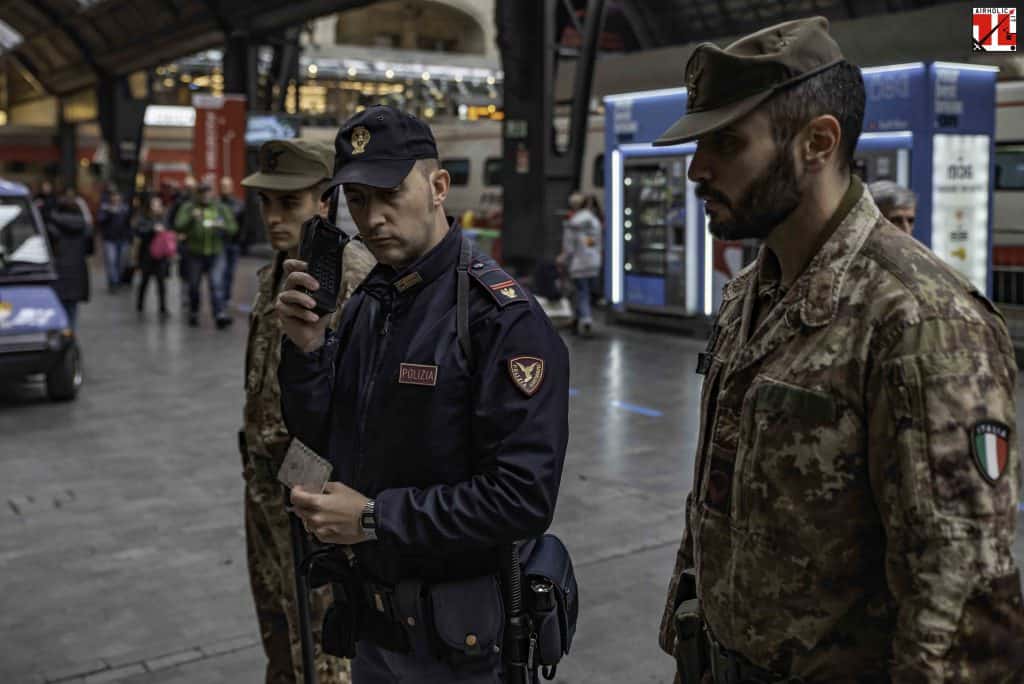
left=655, top=17, right=1024, bottom=684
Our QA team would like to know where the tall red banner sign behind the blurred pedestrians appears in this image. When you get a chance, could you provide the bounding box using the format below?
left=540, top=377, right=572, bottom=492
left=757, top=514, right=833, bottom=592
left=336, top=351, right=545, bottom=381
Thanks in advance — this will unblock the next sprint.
left=193, top=95, right=246, bottom=198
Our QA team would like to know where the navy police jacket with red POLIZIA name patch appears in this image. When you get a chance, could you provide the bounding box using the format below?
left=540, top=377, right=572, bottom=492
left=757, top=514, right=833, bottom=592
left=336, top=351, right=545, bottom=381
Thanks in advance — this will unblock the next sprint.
left=279, top=223, right=569, bottom=583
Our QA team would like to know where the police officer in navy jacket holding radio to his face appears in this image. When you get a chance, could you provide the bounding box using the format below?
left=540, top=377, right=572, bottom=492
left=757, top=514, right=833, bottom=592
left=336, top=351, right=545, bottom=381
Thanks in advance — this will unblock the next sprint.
left=276, top=106, right=569, bottom=684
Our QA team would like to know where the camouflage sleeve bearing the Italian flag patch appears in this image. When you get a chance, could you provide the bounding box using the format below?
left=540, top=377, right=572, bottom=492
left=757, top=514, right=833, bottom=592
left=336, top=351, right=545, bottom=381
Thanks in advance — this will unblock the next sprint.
left=866, top=314, right=1024, bottom=682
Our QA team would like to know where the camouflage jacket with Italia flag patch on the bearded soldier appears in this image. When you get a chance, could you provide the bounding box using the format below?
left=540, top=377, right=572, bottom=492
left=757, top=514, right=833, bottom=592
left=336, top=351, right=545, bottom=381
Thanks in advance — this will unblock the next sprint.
left=660, top=181, right=1024, bottom=682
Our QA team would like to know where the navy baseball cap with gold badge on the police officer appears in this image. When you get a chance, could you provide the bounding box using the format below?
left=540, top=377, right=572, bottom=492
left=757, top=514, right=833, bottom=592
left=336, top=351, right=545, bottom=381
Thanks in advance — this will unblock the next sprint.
left=331, top=104, right=437, bottom=193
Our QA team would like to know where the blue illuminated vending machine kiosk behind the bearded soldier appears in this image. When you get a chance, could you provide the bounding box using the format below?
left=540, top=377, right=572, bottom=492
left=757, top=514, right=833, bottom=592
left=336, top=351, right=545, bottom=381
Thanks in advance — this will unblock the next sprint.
left=604, top=62, right=997, bottom=317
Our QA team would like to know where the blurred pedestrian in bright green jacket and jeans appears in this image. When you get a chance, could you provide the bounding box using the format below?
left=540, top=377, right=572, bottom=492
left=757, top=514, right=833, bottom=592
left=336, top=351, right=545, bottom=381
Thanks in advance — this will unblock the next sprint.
left=174, top=183, right=239, bottom=330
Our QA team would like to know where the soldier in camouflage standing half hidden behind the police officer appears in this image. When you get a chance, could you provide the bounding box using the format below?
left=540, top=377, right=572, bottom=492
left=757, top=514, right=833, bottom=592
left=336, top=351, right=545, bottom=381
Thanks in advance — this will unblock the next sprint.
left=241, top=139, right=375, bottom=684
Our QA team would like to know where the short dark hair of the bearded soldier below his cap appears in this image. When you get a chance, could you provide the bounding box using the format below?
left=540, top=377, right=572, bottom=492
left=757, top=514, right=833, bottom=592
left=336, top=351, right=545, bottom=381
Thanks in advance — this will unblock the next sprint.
left=765, top=61, right=864, bottom=170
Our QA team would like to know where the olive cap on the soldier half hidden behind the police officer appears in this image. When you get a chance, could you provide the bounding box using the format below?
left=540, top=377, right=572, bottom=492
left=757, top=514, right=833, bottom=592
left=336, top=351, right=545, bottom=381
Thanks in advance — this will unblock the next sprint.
left=242, top=138, right=334, bottom=191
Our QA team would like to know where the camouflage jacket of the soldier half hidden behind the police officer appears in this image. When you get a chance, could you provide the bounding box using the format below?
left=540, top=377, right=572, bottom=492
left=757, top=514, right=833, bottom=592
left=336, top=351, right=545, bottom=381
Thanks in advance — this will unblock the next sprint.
left=244, top=241, right=376, bottom=477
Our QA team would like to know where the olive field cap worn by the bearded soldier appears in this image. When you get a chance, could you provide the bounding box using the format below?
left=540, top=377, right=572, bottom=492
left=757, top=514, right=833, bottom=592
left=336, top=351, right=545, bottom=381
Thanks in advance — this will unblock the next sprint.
left=653, top=16, right=843, bottom=145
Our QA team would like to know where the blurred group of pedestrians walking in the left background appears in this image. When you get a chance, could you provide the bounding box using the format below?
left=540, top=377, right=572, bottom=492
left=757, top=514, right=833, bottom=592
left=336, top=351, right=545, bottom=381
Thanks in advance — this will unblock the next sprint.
left=34, top=176, right=245, bottom=330
